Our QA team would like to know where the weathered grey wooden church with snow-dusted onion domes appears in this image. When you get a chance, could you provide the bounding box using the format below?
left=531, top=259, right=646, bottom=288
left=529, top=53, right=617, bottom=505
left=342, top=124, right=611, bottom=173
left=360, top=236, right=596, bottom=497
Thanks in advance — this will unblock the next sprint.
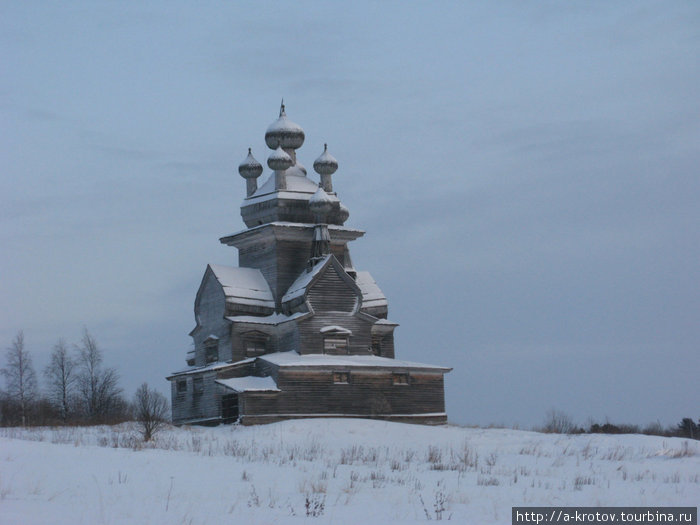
left=168, top=104, right=450, bottom=425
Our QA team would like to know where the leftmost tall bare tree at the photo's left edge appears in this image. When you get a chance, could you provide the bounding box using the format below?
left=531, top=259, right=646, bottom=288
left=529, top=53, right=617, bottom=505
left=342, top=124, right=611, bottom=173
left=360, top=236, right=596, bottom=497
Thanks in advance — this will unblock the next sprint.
left=0, top=330, right=37, bottom=426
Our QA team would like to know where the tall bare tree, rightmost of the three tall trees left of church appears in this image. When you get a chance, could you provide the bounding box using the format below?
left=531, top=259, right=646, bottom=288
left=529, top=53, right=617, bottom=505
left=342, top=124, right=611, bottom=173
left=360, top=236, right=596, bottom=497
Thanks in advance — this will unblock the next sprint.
left=76, top=328, right=123, bottom=423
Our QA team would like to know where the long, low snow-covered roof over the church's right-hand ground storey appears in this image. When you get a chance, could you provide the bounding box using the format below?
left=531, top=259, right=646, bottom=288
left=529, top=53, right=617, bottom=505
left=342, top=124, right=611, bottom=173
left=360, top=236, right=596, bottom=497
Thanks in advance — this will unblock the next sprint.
left=258, top=351, right=452, bottom=372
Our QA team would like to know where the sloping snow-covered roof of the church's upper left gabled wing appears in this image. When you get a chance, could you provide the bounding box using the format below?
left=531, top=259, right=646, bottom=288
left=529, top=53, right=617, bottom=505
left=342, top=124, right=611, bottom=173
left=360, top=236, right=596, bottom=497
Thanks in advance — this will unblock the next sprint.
left=209, top=264, right=275, bottom=308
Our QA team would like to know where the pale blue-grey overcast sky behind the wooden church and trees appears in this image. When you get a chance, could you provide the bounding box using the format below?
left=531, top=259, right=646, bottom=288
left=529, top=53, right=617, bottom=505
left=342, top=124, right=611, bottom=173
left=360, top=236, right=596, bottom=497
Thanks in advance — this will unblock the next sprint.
left=0, top=0, right=700, bottom=428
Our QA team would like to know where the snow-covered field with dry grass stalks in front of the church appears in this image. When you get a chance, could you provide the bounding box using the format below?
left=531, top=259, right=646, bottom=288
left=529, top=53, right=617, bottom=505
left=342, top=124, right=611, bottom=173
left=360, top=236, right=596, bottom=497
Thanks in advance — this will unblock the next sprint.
left=0, top=419, right=700, bottom=525
